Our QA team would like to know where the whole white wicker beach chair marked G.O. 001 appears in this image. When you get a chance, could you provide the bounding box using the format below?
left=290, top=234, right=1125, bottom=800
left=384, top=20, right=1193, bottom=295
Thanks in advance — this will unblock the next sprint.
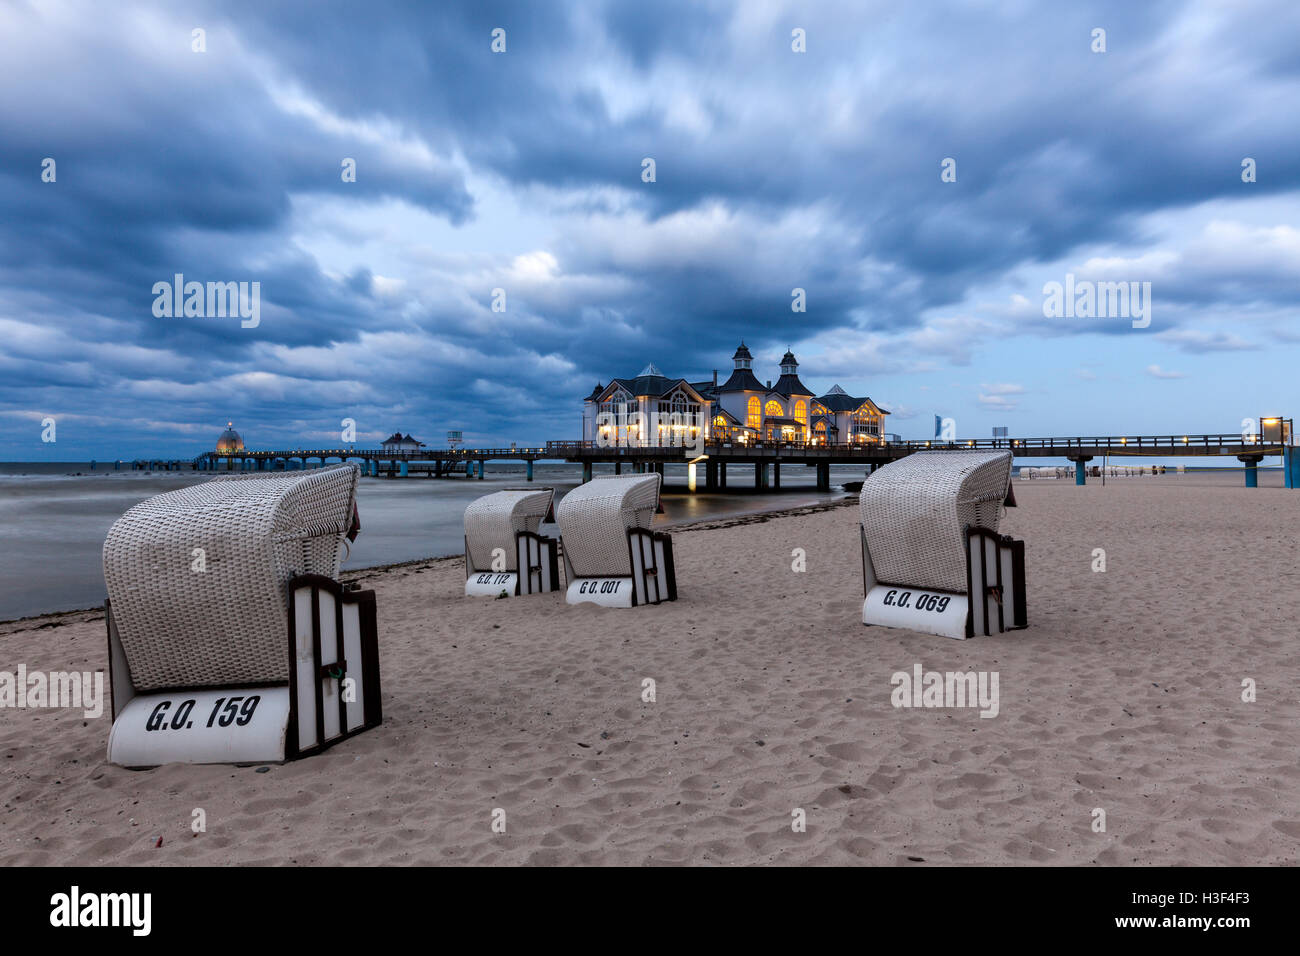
left=555, top=473, right=677, bottom=607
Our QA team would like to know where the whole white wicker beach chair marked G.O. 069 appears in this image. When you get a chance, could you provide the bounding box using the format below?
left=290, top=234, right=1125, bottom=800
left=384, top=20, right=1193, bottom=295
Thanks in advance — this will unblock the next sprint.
left=859, top=450, right=1027, bottom=639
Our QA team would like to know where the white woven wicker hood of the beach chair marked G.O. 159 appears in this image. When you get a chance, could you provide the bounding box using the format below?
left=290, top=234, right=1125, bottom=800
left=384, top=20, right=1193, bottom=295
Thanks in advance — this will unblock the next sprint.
left=104, top=464, right=358, bottom=691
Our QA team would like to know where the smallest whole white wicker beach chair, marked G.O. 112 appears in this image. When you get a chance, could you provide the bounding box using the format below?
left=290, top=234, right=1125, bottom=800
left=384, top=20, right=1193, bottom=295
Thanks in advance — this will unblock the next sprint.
left=465, top=488, right=560, bottom=597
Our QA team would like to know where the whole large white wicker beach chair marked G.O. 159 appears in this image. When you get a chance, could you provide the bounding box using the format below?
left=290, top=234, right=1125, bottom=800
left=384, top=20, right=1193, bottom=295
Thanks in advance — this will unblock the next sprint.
left=104, top=464, right=382, bottom=766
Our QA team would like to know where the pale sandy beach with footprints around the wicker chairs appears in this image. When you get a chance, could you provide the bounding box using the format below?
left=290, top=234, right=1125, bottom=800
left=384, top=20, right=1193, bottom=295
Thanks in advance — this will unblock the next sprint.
left=0, top=473, right=1300, bottom=866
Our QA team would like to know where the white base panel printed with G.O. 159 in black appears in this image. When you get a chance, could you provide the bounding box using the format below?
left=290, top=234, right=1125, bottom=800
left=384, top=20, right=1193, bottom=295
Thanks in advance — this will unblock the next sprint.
left=108, top=685, right=289, bottom=767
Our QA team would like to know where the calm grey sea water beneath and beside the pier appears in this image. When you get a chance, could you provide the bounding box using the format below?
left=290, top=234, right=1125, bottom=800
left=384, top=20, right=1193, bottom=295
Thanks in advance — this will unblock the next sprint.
left=0, top=462, right=863, bottom=620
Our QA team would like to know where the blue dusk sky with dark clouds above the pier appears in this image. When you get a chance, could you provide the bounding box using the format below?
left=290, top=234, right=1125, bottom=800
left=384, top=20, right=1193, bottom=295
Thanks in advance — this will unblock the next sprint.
left=0, top=0, right=1300, bottom=460
